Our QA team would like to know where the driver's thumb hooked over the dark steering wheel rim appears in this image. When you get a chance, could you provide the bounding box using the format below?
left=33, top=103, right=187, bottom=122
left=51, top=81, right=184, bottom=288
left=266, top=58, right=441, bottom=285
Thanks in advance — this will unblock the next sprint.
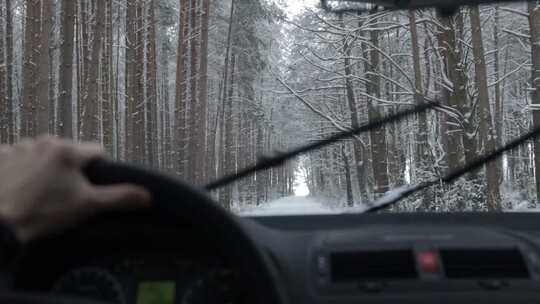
left=89, top=184, right=152, bottom=208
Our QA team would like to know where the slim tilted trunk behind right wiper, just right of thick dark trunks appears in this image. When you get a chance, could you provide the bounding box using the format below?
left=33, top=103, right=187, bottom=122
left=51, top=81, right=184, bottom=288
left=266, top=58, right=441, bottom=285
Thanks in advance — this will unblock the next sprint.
left=470, top=6, right=501, bottom=210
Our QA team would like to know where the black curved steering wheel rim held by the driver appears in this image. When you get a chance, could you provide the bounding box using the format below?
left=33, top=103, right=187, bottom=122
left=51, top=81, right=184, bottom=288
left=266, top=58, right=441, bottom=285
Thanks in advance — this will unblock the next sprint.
left=0, top=160, right=286, bottom=304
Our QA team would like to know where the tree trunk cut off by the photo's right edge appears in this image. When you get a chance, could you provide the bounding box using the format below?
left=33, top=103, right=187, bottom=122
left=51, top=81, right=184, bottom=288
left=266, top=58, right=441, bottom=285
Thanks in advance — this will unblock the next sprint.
left=527, top=1, right=540, bottom=202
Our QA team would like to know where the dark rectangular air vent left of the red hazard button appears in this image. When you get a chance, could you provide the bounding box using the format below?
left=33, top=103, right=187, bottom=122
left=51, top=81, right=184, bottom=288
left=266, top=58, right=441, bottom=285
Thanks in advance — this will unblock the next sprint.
left=330, top=250, right=418, bottom=282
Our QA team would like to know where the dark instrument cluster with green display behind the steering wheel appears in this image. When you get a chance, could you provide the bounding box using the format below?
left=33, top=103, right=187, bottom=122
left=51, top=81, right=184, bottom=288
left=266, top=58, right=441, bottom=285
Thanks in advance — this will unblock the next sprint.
left=12, top=216, right=246, bottom=304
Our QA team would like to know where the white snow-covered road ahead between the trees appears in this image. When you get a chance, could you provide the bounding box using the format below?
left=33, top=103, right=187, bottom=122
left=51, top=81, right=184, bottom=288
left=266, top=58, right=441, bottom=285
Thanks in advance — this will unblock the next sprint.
left=239, top=196, right=338, bottom=216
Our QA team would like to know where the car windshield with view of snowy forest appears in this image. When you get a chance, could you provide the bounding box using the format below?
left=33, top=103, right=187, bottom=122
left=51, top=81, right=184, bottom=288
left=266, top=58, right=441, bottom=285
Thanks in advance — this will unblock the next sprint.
left=0, top=0, right=540, bottom=215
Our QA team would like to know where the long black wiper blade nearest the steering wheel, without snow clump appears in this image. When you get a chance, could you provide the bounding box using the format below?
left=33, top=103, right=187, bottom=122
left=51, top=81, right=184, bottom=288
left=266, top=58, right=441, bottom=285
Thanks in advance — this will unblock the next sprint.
left=205, top=101, right=440, bottom=190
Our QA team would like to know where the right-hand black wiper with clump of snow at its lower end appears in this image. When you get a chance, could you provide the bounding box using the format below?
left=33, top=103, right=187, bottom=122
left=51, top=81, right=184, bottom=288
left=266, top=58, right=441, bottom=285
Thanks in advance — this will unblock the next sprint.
left=362, top=127, right=540, bottom=213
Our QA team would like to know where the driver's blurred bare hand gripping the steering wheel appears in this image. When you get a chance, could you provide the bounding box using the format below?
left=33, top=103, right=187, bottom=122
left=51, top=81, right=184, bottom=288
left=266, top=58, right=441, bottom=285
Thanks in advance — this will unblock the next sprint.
left=0, top=137, right=151, bottom=243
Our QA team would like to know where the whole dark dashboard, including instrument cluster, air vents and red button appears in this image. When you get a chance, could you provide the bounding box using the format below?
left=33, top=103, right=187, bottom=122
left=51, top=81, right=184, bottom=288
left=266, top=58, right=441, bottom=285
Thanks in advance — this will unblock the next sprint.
left=8, top=213, right=540, bottom=304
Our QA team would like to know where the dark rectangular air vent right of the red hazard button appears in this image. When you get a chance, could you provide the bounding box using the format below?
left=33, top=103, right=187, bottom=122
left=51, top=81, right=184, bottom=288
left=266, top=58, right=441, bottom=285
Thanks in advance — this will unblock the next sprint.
left=440, top=249, right=529, bottom=279
